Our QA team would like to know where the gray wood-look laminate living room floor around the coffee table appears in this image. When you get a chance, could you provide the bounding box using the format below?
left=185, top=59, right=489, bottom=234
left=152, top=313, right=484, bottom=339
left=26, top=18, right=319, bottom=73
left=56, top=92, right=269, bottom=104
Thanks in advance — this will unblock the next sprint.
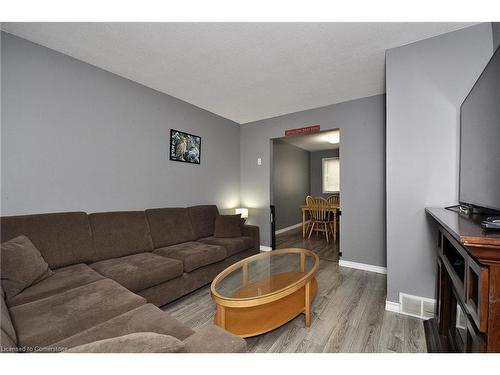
left=163, top=259, right=426, bottom=353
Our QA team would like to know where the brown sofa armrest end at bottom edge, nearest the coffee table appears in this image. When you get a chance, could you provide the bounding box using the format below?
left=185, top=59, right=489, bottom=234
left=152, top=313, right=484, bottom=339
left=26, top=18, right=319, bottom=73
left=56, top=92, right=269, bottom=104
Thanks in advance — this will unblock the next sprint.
left=184, top=324, right=247, bottom=353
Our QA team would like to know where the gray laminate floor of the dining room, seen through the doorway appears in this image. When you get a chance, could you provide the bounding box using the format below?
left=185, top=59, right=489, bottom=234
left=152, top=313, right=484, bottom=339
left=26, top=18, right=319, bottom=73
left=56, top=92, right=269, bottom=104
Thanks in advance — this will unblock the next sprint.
left=276, top=228, right=339, bottom=261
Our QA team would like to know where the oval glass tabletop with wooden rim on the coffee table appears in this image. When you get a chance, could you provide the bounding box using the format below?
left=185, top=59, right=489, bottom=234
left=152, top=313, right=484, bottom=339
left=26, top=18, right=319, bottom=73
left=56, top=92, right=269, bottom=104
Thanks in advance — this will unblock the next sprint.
left=211, top=248, right=319, bottom=301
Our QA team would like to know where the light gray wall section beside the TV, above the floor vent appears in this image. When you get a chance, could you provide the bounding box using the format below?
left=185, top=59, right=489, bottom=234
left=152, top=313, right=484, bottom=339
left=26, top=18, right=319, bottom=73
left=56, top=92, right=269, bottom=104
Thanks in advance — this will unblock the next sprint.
left=384, top=24, right=493, bottom=301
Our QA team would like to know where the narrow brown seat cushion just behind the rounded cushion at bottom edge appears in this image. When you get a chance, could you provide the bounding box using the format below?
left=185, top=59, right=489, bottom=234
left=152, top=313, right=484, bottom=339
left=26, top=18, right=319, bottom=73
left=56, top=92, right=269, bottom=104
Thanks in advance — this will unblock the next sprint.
left=52, top=303, right=194, bottom=350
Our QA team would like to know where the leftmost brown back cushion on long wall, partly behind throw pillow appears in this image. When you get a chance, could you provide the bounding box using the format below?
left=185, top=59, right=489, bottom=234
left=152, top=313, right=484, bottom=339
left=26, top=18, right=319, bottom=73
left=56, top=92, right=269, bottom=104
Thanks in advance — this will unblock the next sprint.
left=0, top=212, right=94, bottom=269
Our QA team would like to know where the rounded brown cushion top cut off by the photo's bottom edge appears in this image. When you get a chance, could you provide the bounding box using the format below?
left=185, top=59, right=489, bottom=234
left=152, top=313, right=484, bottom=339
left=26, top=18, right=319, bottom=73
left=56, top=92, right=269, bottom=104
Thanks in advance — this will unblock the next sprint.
left=66, top=332, right=184, bottom=353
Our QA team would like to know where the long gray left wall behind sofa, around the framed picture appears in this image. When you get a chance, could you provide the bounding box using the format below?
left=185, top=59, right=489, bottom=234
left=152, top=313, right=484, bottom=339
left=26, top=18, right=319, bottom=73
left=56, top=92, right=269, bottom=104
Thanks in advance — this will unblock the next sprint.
left=1, top=33, right=240, bottom=215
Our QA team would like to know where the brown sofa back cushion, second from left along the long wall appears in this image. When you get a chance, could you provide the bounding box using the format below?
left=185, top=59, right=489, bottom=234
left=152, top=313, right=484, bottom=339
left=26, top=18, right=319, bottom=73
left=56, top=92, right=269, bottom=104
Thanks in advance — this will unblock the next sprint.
left=89, top=211, right=153, bottom=261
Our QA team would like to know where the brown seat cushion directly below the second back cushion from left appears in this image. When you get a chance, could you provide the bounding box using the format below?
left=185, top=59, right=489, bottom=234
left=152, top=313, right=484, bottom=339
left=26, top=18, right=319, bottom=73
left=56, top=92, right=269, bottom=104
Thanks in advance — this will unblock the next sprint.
left=90, top=253, right=183, bottom=292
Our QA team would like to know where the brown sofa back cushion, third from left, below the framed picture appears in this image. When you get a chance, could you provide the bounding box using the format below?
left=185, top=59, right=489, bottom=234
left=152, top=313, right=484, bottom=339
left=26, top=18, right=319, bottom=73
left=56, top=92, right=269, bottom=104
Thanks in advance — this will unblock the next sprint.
left=146, top=208, right=196, bottom=248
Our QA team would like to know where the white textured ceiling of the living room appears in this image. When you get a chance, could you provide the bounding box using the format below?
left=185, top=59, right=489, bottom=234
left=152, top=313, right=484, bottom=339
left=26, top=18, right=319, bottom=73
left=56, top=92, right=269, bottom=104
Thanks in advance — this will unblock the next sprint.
left=2, top=23, right=471, bottom=123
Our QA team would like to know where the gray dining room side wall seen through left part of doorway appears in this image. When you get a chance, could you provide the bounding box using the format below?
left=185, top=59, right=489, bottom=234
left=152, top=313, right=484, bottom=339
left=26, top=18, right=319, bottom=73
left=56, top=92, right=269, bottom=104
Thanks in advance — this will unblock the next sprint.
left=271, top=140, right=310, bottom=230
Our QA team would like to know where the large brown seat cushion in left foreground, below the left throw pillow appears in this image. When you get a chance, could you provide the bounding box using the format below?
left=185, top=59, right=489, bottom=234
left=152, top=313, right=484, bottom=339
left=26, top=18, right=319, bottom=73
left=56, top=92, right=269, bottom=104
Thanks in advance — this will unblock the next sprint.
left=10, top=279, right=146, bottom=350
